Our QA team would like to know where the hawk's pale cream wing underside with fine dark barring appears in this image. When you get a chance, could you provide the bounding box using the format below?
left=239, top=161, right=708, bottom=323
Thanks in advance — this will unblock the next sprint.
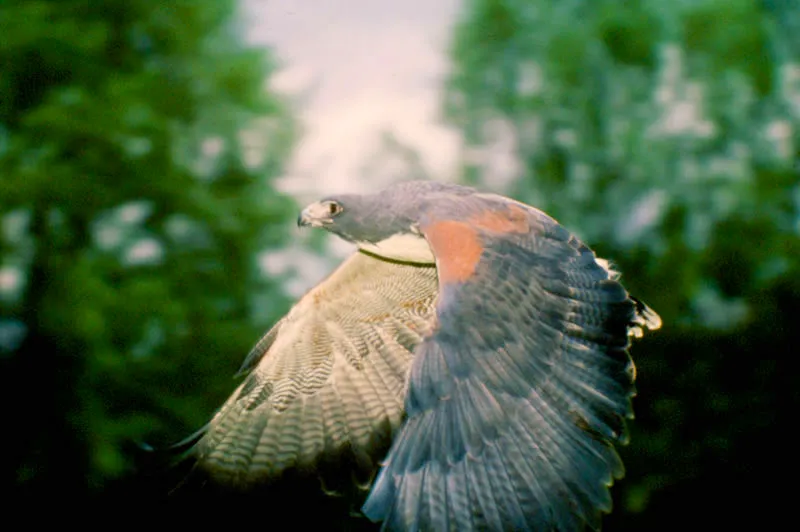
left=193, top=253, right=438, bottom=488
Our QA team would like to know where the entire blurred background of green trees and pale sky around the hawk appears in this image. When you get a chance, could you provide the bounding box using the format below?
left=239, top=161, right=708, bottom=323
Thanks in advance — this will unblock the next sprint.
left=0, top=0, right=800, bottom=530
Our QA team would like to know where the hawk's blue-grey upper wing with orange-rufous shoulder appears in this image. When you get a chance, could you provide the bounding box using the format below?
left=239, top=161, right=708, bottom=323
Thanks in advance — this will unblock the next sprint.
left=363, top=201, right=658, bottom=531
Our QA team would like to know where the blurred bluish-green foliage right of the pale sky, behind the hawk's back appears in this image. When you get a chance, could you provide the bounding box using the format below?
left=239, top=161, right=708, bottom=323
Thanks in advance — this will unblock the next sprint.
left=444, top=0, right=800, bottom=530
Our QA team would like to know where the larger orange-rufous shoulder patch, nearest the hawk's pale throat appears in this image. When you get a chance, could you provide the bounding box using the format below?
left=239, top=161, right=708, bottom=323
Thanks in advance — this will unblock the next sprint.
left=422, top=220, right=483, bottom=283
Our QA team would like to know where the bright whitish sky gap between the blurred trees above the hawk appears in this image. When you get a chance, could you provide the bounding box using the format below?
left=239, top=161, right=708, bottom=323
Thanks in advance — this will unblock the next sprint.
left=242, top=0, right=460, bottom=200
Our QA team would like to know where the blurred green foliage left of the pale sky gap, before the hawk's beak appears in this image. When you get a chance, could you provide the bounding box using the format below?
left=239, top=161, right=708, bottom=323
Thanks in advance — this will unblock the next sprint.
left=0, top=0, right=295, bottom=497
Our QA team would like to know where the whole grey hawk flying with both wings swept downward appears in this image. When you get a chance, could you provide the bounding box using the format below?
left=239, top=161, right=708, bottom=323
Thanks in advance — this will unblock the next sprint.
left=192, top=181, right=660, bottom=531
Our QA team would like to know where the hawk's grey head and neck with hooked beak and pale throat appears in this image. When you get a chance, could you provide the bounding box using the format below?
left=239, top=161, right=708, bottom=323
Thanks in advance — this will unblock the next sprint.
left=297, top=181, right=472, bottom=264
